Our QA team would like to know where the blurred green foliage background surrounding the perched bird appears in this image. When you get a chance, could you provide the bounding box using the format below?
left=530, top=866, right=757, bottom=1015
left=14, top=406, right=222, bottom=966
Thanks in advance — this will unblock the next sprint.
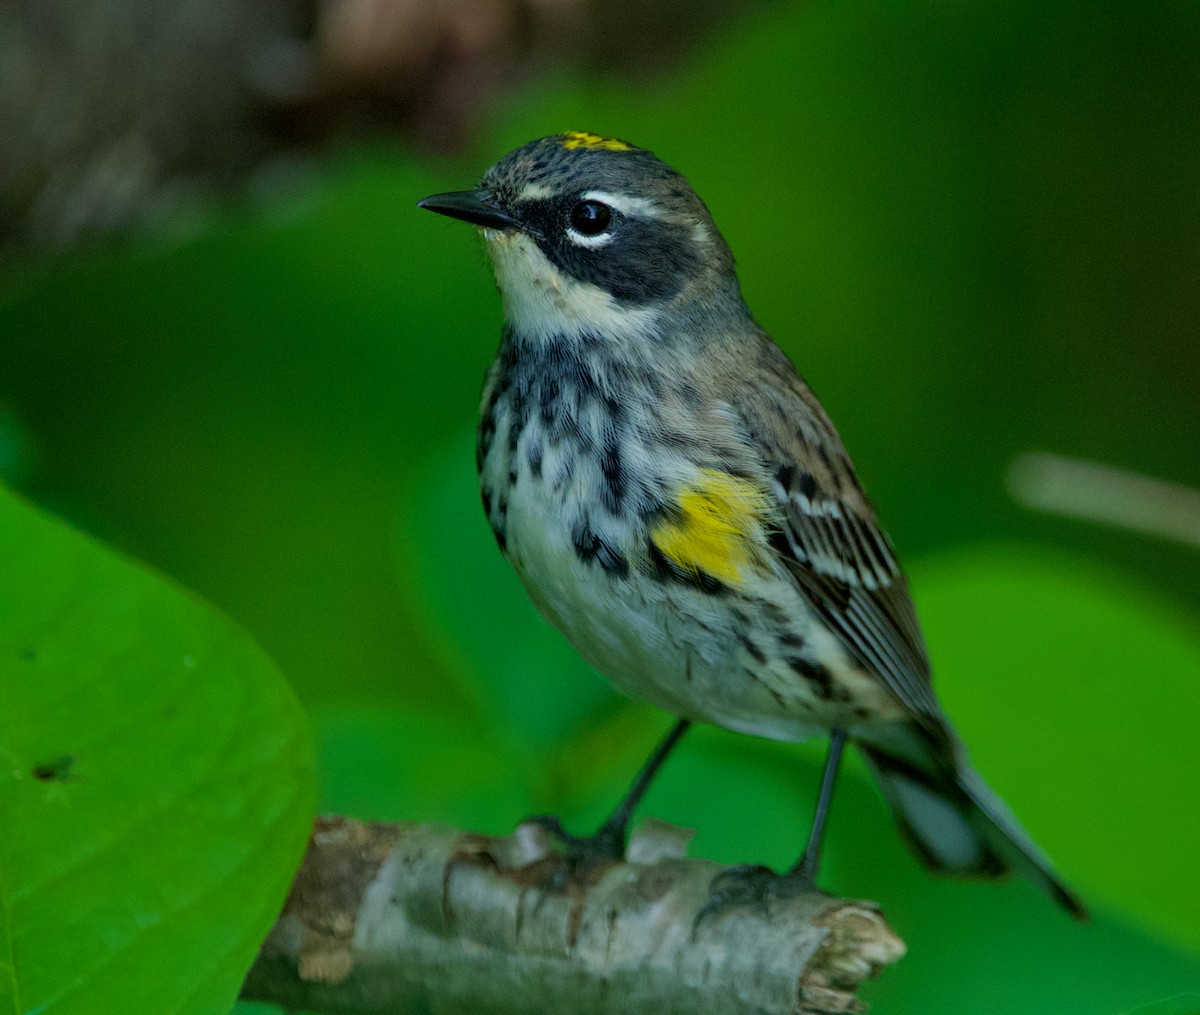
left=0, top=0, right=1200, bottom=1015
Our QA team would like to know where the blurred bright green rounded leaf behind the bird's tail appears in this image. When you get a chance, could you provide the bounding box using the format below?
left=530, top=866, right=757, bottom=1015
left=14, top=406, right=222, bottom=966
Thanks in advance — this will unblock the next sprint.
left=913, top=547, right=1200, bottom=951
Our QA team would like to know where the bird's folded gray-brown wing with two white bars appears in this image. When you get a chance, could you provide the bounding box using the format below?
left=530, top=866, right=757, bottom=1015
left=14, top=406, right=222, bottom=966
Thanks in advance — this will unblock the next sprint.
left=737, top=347, right=944, bottom=732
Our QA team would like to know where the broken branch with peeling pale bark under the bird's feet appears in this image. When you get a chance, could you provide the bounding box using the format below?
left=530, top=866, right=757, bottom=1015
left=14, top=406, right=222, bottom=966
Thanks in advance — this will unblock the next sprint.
left=242, top=818, right=905, bottom=1015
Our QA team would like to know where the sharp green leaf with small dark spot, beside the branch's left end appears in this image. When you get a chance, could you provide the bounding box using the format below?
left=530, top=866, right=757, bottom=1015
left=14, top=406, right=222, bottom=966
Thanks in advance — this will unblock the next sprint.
left=0, top=491, right=312, bottom=1015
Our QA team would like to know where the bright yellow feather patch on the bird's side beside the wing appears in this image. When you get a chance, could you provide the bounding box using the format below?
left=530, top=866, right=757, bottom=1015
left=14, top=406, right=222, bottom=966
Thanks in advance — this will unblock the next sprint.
left=650, top=469, right=770, bottom=585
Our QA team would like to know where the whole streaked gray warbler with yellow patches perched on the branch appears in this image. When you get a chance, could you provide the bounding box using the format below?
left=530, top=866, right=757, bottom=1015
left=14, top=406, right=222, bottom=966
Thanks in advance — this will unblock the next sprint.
left=420, top=133, right=1086, bottom=918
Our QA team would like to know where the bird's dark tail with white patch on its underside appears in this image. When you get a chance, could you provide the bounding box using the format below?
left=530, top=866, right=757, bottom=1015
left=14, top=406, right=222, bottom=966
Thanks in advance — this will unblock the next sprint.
left=859, top=744, right=1087, bottom=920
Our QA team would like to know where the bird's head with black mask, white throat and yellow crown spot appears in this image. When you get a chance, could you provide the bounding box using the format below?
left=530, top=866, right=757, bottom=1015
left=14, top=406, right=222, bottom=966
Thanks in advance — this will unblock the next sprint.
left=420, top=133, right=740, bottom=341
